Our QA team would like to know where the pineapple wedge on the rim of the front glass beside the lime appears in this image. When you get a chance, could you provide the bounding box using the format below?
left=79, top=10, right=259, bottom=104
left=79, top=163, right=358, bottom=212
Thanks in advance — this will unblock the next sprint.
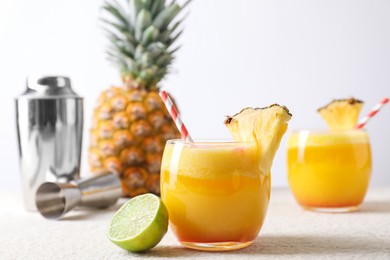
left=224, top=104, right=292, bottom=174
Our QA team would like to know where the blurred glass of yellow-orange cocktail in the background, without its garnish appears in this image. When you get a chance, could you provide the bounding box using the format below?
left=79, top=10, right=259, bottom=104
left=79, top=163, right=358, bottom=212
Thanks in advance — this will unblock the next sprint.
left=287, top=130, right=371, bottom=212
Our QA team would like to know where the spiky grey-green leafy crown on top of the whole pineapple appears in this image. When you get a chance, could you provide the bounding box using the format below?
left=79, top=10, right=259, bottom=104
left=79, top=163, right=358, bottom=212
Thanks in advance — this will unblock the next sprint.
left=102, top=0, right=191, bottom=88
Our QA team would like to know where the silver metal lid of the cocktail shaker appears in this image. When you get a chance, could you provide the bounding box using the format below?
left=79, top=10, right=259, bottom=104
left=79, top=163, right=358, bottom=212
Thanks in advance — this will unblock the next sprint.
left=19, top=76, right=81, bottom=99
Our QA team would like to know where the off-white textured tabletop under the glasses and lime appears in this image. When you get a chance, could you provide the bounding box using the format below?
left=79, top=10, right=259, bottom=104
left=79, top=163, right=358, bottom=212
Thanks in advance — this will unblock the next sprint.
left=0, top=188, right=390, bottom=259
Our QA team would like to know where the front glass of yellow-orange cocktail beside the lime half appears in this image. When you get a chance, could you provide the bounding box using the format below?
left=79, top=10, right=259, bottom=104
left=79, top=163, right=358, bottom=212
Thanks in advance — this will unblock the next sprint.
left=161, top=140, right=270, bottom=250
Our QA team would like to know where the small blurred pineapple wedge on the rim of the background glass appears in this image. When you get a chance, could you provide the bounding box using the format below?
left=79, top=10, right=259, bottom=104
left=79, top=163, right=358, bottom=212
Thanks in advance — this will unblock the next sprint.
left=317, top=98, right=363, bottom=130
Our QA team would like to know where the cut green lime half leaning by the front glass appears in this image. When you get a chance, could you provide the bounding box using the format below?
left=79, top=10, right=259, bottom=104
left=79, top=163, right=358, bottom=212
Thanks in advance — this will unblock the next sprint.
left=108, top=193, right=168, bottom=252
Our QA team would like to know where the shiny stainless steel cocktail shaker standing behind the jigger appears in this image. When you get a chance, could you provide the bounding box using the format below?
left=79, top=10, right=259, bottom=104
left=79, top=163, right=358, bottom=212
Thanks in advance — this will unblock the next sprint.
left=16, top=76, right=83, bottom=210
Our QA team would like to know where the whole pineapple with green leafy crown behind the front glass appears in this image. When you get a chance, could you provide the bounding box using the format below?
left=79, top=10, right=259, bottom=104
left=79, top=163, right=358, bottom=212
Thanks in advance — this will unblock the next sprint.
left=89, top=0, right=189, bottom=197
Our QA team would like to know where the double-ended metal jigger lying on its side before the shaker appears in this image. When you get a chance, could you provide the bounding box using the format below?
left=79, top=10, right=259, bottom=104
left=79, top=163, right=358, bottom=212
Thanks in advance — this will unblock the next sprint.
left=35, top=172, right=122, bottom=219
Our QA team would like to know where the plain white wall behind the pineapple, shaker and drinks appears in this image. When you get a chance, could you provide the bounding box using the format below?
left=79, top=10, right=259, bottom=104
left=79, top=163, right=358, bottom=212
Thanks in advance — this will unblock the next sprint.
left=0, top=0, right=390, bottom=189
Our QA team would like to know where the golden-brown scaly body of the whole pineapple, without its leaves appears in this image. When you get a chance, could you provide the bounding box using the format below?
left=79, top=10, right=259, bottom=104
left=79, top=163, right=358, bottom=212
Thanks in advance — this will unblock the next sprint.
left=88, top=86, right=180, bottom=197
